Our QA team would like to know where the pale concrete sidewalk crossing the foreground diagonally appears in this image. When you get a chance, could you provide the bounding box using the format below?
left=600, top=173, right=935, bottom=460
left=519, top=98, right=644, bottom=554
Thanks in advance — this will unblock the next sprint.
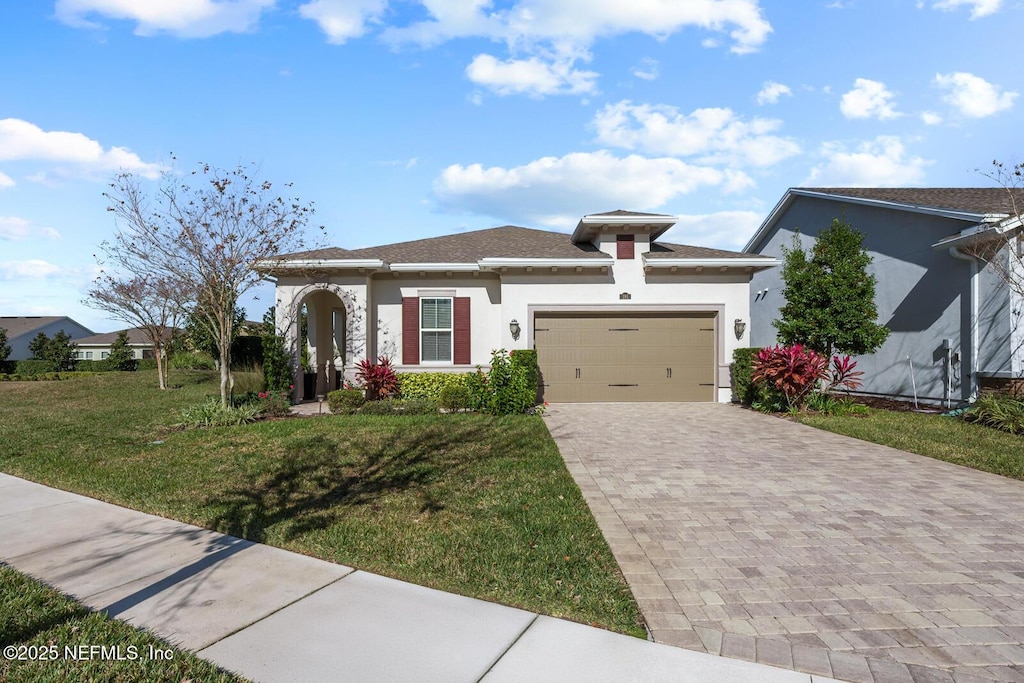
left=0, top=474, right=833, bottom=683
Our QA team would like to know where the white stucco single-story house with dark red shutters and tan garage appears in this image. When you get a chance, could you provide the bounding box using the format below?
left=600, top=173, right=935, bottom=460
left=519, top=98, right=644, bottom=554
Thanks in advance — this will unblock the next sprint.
left=258, top=211, right=778, bottom=402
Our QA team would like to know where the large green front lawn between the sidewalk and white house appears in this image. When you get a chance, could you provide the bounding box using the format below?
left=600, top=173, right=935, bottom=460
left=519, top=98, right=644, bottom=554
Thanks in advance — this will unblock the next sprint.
left=0, top=373, right=644, bottom=637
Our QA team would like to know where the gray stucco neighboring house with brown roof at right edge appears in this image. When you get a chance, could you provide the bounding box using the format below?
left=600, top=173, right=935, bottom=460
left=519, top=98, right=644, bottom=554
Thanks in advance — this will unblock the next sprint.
left=743, top=187, right=1024, bottom=404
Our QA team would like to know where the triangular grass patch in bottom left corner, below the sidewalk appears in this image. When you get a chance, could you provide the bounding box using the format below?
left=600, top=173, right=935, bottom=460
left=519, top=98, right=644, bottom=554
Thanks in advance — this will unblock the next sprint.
left=0, top=564, right=245, bottom=683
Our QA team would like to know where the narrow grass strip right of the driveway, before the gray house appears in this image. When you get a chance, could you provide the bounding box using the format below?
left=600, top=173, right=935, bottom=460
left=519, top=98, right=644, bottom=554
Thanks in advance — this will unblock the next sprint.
left=797, top=409, right=1024, bottom=479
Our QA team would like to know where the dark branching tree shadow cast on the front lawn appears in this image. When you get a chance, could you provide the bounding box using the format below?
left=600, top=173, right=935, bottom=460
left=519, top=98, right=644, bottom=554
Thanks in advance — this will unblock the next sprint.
left=204, top=422, right=489, bottom=543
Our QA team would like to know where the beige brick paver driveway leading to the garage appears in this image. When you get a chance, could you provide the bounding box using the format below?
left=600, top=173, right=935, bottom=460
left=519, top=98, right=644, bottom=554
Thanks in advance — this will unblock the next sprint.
left=546, top=403, right=1024, bottom=683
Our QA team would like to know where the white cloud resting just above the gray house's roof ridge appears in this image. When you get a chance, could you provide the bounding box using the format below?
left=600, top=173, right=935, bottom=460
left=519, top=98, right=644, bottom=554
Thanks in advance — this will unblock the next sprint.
left=803, top=135, right=931, bottom=187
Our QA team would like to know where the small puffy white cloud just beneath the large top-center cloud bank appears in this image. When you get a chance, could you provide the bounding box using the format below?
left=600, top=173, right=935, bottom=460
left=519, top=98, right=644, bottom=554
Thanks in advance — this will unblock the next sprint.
left=466, top=54, right=597, bottom=97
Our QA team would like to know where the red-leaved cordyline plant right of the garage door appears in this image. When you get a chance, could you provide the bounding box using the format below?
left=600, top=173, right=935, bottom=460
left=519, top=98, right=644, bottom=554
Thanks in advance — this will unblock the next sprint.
left=751, top=344, right=864, bottom=408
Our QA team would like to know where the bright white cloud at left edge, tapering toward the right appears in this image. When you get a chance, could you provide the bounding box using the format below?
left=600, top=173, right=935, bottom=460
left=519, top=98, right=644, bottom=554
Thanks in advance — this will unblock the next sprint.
left=0, top=119, right=160, bottom=178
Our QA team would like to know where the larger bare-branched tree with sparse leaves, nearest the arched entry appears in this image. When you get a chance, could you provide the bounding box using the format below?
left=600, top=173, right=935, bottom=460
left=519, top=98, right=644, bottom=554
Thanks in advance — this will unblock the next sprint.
left=105, top=164, right=313, bottom=405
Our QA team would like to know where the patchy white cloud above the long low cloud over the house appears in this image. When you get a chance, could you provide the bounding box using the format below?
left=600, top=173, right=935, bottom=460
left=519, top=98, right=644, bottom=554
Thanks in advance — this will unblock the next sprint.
left=594, top=100, right=800, bottom=166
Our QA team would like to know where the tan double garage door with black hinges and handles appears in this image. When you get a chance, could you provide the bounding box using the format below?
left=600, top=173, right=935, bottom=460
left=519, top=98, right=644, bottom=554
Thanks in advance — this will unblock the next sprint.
left=534, top=312, right=715, bottom=403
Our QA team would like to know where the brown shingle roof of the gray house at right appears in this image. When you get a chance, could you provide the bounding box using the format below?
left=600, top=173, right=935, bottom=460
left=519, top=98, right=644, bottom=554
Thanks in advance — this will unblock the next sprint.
left=794, top=187, right=1024, bottom=215
